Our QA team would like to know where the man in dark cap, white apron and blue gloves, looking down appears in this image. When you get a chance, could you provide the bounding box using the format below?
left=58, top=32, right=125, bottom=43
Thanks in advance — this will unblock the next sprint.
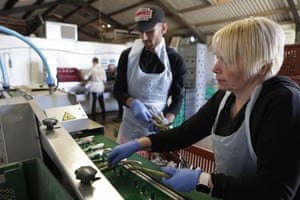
left=113, top=6, right=186, bottom=143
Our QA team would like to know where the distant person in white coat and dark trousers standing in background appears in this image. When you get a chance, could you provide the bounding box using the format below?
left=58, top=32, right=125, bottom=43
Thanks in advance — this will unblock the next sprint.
left=86, top=57, right=106, bottom=124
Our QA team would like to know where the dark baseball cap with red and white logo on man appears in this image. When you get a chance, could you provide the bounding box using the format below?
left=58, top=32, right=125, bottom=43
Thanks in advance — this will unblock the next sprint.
left=134, top=7, right=166, bottom=32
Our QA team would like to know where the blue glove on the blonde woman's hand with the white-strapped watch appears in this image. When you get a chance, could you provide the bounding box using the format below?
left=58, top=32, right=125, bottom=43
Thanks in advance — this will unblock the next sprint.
left=161, top=167, right=202, bottom=192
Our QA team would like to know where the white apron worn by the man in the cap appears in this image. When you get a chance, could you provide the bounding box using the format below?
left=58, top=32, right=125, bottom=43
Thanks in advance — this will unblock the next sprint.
left=117, top=39, right=172, bottom=143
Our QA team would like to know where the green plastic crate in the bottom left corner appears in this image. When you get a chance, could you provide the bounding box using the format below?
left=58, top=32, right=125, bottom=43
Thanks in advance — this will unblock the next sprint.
left=0, top=158, right=73, bottom=200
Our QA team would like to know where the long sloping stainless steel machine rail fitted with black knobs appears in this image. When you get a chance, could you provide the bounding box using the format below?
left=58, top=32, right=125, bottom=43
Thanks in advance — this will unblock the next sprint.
left=30, top=100, right=123, bottom=200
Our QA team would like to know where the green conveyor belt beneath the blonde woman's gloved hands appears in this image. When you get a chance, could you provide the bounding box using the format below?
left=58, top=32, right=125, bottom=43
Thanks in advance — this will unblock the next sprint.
left=89, top=135, right=216, bottom=200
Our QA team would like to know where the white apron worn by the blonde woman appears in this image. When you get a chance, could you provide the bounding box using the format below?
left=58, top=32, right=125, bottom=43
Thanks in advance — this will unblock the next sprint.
left=212, top=86, right=261, bottom=176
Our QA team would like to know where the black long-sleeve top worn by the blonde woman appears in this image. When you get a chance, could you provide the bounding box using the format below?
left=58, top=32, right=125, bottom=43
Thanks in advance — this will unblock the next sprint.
left=149, top=76, right=300, bottom=200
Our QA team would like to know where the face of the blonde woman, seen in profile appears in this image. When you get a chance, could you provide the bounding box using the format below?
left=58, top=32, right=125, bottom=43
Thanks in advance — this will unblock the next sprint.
left=212, top=53, right=248, bottom=92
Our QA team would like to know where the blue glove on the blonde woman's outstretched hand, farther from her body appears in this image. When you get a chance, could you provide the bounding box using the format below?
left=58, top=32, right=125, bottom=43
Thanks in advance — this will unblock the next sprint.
left=107, top=140, right=142, bottom=167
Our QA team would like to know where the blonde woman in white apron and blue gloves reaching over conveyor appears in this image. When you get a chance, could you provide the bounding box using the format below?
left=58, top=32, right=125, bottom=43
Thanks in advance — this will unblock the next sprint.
left=108, top=17, right=300, bottom=200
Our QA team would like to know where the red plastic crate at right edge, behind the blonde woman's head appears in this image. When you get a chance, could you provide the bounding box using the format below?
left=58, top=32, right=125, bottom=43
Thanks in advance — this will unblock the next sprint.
left=279, top=44, right=300, bottom=76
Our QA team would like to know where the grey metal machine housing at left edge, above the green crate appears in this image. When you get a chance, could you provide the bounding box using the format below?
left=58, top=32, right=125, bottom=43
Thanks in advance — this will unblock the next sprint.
left=0, top=97, right=42, bottom=163
